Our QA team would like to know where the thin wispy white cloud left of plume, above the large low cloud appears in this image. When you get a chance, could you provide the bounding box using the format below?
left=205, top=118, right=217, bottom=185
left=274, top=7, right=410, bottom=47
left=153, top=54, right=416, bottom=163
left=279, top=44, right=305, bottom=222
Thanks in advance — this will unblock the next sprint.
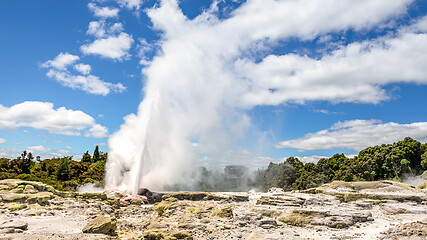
left=47, top=69, right=126, bottom=96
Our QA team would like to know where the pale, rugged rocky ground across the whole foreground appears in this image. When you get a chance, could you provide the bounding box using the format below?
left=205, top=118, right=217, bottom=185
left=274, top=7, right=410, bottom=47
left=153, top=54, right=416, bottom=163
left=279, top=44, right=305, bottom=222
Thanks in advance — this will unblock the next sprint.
left=0, top=179, right=427, bottom=240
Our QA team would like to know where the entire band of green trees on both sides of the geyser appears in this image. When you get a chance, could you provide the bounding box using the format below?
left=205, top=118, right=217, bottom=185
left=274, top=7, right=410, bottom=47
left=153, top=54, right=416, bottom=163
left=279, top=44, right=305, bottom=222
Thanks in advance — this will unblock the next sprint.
left=0, top=137, right=427, bottom=191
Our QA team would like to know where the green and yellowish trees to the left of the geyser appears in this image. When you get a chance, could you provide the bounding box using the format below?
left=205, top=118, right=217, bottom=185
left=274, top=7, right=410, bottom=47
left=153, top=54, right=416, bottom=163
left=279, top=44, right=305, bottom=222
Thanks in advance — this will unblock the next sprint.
left=0, top=146, right=107, bottom=190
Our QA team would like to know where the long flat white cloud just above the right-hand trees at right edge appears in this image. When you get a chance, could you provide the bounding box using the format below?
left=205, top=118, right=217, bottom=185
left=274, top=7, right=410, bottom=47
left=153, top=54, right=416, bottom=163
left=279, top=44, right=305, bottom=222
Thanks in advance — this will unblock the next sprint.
left=276, top=120, right=427, bottom=151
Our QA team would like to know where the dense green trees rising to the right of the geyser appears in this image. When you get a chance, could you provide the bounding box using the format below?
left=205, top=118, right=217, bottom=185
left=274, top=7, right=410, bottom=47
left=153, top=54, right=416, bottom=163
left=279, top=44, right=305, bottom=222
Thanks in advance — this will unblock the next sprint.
left=255, top=137, right=427, bottom=190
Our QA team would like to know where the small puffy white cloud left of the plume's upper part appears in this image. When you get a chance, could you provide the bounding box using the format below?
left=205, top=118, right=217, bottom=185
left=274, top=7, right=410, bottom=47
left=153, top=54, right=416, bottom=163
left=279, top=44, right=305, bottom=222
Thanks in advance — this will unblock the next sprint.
left=80, top=33, right=133, bottom=61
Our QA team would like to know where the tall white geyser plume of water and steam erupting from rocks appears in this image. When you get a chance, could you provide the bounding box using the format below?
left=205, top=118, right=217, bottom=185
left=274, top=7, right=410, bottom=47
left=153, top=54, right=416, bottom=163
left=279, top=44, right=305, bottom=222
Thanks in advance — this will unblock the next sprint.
left=106, top=1, right=249, bottom=193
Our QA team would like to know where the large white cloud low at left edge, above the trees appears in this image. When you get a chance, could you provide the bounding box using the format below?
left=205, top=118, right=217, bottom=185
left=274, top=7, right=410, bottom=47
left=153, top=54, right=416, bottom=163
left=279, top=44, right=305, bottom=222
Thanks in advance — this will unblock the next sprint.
left=0, top=101, right=107, bottom=137
